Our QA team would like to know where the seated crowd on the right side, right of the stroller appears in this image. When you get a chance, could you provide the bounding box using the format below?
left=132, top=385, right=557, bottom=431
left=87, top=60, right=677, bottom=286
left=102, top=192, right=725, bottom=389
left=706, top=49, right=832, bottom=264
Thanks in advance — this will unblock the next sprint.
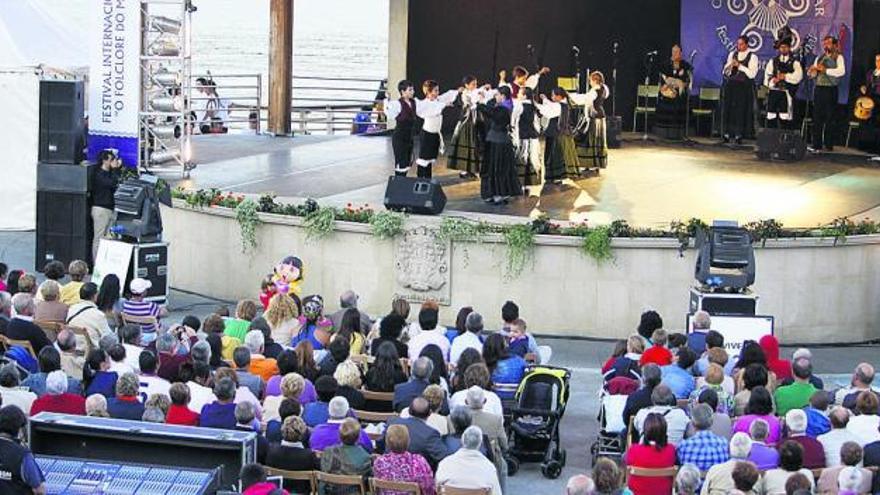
left=567, top=311, right=880, bottom=495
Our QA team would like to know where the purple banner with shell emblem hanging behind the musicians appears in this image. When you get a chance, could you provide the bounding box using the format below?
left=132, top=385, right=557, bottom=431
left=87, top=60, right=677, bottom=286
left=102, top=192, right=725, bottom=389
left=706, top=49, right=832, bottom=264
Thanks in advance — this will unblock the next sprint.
left=681, top=0, right=853, bottom=103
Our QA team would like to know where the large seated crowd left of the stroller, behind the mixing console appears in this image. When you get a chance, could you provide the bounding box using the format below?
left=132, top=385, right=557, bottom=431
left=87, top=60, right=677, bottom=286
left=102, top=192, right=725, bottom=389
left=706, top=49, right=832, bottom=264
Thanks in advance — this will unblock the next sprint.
left=0, top=261, right=552, bottom=495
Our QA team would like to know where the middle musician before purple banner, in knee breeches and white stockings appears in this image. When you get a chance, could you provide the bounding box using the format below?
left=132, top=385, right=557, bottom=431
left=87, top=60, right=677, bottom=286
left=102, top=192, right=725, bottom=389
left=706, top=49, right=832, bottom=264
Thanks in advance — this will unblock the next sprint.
left=764, top=38, right=804, bottom=129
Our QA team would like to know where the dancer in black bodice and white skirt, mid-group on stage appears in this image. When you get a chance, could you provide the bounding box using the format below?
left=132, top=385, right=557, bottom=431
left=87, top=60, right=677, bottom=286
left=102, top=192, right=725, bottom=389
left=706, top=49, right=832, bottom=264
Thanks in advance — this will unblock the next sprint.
left=511, top=88, right=544, bottom=196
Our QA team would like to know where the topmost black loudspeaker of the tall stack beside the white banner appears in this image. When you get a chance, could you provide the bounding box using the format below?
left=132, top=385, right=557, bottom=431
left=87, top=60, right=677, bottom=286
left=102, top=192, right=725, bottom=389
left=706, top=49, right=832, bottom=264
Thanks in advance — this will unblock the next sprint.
left=39, top=80, right=85, bottom=164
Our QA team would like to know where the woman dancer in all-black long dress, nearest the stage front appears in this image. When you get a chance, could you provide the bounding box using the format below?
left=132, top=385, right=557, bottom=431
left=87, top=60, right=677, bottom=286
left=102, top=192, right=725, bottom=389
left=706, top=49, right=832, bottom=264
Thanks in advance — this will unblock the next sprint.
left=477, top=86, right=522, bottom=205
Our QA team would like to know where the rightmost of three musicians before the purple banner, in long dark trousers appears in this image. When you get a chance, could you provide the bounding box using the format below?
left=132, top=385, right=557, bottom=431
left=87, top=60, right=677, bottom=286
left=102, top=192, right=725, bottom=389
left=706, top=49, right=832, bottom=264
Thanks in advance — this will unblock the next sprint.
left=807, top=36, right=846, bottom=151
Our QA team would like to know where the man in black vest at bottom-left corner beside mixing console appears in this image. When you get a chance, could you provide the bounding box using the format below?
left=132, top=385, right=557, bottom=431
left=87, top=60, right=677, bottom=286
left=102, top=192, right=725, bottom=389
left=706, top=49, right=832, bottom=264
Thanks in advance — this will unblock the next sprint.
left=0, top=406, right=46, bottom=495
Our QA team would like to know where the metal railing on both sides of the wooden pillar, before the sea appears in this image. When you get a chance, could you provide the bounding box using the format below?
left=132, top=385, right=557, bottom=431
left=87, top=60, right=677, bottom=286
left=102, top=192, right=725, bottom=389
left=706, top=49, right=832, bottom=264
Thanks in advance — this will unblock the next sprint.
left=192, top=74, right=387, bottom=135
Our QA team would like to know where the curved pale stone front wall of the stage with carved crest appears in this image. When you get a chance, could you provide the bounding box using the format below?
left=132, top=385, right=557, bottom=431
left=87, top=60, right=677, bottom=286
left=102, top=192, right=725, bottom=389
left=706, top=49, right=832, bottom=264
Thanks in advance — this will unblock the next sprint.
left=162, top=201, right=880, bottom=343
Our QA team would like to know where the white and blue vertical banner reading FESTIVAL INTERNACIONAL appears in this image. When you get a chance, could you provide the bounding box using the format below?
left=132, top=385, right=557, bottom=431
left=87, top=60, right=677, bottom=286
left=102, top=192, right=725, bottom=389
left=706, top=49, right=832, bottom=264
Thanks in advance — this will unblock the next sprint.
left=87, top=0, right=141, bottom=167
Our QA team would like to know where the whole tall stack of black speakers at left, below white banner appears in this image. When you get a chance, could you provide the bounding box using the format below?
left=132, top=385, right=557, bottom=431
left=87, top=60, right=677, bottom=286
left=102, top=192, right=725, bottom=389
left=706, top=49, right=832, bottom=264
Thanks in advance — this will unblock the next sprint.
left=35, top=80, right=92, bottom=270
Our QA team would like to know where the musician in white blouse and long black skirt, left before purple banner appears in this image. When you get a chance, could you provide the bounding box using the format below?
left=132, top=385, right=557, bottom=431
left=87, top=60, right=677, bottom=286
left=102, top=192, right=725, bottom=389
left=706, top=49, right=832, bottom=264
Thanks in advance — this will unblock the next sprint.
left=723, top=36, right=758, bottom=144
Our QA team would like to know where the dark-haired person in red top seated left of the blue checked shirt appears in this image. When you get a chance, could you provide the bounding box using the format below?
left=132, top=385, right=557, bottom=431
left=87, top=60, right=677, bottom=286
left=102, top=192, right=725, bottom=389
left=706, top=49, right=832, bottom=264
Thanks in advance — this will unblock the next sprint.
left=626, top=413, right=675, bottom=495
